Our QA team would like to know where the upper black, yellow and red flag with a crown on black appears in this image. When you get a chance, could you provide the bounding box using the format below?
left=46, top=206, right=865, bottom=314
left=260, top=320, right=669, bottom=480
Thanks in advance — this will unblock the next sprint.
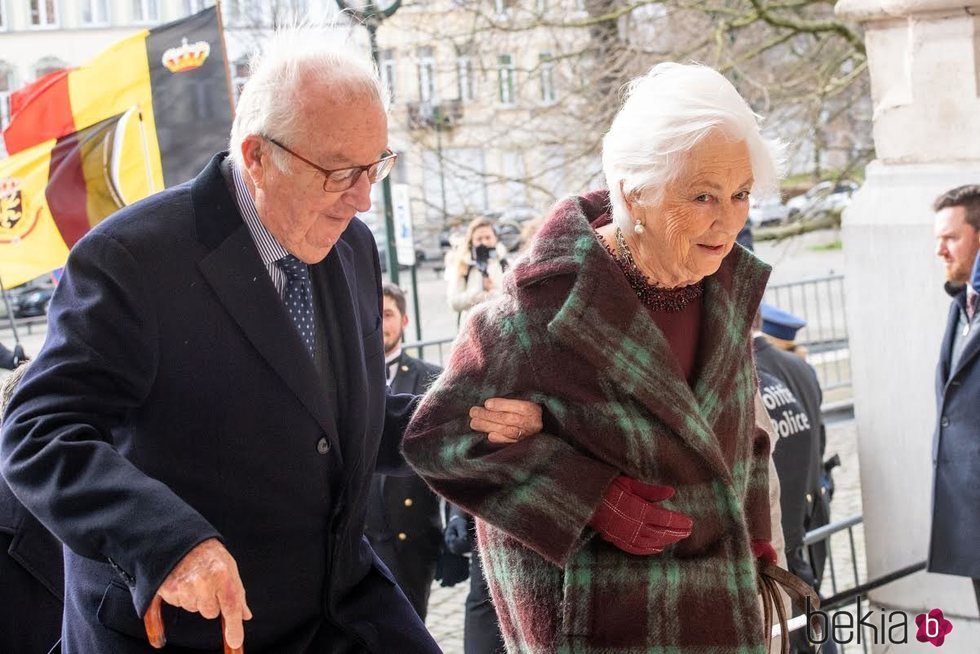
left=3, top=7, right=232, bottom=197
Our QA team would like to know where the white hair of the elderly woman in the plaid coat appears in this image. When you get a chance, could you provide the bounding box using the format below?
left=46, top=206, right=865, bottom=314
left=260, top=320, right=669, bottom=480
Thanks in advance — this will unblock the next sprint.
left=602, top=62, right=781, bottom=229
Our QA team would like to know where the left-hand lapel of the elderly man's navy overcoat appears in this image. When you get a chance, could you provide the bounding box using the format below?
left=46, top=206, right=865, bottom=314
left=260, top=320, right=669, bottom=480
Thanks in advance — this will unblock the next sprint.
left=192, top=158, right=340, bottom=453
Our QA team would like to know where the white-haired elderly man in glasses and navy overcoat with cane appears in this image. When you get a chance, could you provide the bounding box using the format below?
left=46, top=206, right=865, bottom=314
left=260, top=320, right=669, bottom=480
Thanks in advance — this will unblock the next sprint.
left=2, top=31, right=540, bottom=654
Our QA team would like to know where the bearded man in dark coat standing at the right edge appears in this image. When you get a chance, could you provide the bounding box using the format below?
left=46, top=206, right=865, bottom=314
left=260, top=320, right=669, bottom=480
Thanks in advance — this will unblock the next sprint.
left=928, top=184, right=980, bottom=607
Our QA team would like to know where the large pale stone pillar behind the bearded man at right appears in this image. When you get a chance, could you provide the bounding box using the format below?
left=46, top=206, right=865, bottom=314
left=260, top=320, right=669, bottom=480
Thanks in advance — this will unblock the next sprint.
left=836, top=0, right=980, bottom=654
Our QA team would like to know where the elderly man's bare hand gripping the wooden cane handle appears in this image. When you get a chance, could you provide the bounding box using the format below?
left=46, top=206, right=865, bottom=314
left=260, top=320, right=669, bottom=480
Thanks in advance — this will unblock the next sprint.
left=143, top=538, right=252, bottom=651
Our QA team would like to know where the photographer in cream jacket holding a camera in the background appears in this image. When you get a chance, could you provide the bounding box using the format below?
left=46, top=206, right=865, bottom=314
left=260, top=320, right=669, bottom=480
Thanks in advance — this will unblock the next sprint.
left=446, top=218, right=509, bottom=325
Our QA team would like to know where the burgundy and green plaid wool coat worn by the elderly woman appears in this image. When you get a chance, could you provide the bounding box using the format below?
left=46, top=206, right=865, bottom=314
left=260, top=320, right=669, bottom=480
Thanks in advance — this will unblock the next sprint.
left=403, top=193, right=770, bottom=654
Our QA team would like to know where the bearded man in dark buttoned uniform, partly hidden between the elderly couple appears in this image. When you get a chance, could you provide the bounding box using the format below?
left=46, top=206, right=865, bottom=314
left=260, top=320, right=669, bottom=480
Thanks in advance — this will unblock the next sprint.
left=364, top=284, right=442, bottom=620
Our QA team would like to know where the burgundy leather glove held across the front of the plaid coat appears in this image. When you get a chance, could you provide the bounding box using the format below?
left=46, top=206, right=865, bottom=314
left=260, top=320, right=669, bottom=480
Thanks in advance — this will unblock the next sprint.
left=589, top=475, right=694, bottom=556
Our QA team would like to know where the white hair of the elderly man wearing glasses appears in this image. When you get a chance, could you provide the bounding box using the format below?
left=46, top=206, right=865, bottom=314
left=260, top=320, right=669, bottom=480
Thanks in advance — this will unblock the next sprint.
left=228, top=24, right=391, bottom=172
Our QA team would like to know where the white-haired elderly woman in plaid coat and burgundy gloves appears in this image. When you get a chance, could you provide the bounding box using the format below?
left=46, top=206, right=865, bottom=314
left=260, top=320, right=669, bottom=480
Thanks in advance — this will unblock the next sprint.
left=404, top=64, right=776, bottom=654
